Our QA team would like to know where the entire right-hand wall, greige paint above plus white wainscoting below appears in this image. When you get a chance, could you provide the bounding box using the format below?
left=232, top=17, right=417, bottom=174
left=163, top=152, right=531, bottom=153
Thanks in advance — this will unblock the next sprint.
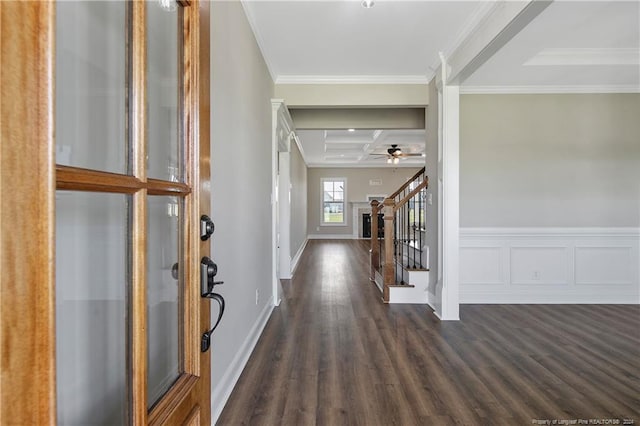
left=460, top=94, right=640, bottom=303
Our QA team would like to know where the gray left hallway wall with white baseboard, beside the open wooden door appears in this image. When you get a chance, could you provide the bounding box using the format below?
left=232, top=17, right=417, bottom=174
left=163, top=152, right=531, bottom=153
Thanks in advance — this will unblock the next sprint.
left=211, top=2, right=273, bottom=422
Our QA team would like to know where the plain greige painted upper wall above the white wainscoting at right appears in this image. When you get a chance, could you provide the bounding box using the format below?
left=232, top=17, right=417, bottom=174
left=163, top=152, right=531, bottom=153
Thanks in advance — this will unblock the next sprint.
left=460, top=94, right=640, bottom=227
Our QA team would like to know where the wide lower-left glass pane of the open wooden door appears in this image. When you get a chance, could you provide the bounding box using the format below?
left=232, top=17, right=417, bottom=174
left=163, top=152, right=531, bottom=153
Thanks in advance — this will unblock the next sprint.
left=56, top=191, right=128, bottom=425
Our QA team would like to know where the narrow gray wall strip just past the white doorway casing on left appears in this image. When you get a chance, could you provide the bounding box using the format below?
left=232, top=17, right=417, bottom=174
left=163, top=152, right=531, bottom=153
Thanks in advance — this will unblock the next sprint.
left=290, top=142, right=307, bottom=257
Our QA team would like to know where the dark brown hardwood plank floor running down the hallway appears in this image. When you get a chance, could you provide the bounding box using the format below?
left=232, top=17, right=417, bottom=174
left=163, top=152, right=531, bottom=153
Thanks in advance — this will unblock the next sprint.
left=217, top=240, right=640, bottom=425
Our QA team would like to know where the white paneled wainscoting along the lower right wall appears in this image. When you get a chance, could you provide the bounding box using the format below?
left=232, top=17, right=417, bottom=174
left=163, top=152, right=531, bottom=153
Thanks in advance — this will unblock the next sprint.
left=460, top=228, right=640, bottom=304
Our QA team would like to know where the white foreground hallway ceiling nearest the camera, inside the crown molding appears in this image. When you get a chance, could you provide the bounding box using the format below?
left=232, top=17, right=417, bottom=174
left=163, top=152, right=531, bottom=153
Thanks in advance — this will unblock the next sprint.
left=243, top=0, right=483, bottom=83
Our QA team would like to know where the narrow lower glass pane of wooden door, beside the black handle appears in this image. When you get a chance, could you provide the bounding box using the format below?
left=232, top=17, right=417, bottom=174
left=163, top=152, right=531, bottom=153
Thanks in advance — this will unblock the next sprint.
left=147, top=197, right=182, bottom=406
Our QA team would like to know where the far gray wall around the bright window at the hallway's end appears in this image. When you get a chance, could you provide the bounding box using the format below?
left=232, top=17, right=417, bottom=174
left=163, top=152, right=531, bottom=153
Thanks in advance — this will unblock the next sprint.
left=307, top=167, right=419, bottom=235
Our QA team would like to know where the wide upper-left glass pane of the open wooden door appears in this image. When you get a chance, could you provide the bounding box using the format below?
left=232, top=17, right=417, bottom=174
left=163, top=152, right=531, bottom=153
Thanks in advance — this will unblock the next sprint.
left=56, top=1, right=127, bottom=173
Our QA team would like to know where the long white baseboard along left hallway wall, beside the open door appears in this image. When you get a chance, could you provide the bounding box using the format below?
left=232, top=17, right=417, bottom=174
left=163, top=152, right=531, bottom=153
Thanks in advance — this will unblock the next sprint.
left=211, top=297, right=274, bottom=426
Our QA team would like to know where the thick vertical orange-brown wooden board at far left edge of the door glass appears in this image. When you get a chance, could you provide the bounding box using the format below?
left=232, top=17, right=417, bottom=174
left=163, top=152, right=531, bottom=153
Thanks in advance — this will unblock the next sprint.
left=0, top=1, right=56, bottom=425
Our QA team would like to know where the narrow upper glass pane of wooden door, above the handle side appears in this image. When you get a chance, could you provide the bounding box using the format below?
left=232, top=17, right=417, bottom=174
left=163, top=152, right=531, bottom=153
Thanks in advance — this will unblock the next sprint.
left=147, top=0, right=182, bottom=181
